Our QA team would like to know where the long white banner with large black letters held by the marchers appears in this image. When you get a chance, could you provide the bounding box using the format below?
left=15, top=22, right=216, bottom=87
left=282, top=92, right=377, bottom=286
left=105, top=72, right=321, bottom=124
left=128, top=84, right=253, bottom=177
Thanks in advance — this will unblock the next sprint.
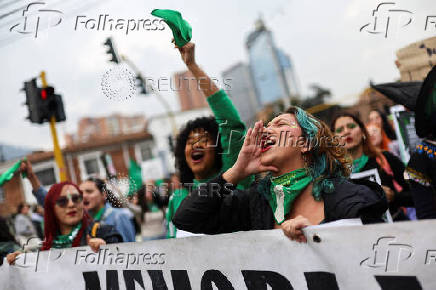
left=0, top=221, right=436, bottom=290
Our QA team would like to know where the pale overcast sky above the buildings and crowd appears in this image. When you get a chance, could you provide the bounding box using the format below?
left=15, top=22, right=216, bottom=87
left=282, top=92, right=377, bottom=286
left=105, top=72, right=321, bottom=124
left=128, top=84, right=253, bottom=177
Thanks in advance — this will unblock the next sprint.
left=0, top=0, right=436, bottom=149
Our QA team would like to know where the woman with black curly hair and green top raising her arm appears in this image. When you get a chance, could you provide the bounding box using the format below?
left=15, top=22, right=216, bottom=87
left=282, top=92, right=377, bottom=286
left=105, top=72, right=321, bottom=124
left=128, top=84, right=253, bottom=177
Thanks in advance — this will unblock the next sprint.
left=166, top=42, right=251, bottom=238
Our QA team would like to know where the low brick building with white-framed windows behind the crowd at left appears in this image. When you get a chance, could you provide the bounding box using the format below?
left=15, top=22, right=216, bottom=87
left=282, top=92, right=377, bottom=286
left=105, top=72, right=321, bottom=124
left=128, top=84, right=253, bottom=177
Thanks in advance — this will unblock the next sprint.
left=0, top=132, right=157, bottom=216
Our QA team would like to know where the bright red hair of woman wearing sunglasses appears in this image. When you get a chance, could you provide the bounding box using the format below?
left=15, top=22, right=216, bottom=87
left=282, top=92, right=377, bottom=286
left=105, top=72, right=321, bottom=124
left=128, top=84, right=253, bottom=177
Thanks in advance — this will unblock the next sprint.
left=41, top=181, right=91, bottom=251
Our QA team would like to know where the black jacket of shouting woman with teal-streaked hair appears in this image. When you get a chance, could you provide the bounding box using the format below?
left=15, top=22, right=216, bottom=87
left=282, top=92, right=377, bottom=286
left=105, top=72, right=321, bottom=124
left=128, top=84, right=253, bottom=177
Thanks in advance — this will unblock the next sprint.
left=173, top=175, right=387, bottom=234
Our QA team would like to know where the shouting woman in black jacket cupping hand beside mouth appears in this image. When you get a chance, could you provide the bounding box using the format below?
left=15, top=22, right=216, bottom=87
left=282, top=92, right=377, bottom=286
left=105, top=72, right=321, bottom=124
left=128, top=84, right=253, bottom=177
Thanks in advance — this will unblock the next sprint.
left=173, top=107, right=387, bottom=242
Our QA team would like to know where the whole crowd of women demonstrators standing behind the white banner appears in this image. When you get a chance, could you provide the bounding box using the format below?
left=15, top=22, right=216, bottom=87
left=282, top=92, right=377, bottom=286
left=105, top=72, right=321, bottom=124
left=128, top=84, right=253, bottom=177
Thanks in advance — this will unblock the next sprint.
left=4, top=42, right=436, bottom=263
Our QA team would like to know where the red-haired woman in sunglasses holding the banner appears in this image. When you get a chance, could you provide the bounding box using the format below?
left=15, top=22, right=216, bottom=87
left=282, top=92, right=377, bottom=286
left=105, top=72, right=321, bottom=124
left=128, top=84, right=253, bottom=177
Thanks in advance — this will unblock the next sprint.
left=7, top=181, right=123, bottom=264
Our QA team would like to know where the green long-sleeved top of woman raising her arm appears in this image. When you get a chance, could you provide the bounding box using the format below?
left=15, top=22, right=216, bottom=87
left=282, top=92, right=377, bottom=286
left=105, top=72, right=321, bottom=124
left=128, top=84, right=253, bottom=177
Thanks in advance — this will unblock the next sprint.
left=166, top=90, right=254, bottom=238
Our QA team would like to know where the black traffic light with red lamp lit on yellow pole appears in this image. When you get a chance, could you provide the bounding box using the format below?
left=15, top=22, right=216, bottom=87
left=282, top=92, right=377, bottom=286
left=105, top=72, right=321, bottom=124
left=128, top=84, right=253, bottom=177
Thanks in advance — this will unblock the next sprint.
left=23, top=79, right=66, bottom=124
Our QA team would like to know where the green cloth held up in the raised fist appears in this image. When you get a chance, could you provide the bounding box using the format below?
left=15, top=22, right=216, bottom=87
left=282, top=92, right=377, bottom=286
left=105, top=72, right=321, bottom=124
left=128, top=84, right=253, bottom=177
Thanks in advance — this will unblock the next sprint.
left=151, top=9, right=192, bottom=47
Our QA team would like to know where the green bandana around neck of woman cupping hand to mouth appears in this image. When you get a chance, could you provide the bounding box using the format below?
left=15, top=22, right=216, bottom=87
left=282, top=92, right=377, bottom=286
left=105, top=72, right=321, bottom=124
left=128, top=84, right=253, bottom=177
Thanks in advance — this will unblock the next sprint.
left=269, top=168, right=312, bottom=225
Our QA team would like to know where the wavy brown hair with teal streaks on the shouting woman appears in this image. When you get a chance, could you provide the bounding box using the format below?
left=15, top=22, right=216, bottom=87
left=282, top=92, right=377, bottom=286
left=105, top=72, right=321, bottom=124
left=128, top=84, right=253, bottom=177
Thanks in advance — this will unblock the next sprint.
left=285, top=106, right=351, bottom=200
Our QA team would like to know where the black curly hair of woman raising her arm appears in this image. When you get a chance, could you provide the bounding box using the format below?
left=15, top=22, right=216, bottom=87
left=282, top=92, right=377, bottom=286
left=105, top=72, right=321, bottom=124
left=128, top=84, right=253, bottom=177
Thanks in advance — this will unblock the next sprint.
left=174, top=117, right=222, bottom=184
